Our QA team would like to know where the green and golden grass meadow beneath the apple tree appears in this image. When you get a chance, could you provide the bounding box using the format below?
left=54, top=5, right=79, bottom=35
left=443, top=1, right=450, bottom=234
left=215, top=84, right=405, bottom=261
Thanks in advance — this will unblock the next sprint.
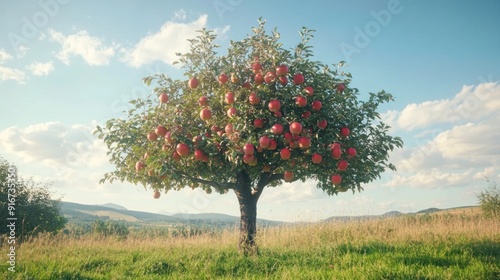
left=0, top=209, right=500, bottom=280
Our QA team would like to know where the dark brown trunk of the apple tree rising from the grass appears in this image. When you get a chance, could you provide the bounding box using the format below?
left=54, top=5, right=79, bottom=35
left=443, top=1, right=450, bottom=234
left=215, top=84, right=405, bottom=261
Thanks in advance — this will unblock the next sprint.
left=234, top=172, right=259, bottom=255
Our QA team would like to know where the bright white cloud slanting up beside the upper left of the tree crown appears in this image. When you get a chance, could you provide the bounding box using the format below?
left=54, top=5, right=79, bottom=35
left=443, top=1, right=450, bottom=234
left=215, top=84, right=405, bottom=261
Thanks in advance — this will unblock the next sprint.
left=122, top=15, right=208, bottom=67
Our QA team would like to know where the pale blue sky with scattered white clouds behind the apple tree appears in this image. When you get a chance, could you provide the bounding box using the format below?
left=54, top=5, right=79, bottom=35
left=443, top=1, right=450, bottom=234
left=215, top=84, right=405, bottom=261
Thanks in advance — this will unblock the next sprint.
left=0, top=0, right=500, bottom=221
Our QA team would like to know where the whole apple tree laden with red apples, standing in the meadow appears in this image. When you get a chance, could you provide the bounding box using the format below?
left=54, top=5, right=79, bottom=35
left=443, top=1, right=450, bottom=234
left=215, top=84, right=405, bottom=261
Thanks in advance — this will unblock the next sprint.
left=95, top=21, right=403, bottom=254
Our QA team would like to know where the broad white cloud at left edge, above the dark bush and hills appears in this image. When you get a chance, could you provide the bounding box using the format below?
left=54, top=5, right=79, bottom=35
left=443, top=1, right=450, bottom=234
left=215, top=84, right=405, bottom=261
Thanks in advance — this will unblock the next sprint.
left=0, top=122, right=108, bottom=169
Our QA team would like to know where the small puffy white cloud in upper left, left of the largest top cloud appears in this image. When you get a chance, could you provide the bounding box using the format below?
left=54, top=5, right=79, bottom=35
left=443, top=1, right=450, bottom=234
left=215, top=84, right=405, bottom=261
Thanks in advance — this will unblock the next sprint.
left=49, top=29, right=116, bottom=66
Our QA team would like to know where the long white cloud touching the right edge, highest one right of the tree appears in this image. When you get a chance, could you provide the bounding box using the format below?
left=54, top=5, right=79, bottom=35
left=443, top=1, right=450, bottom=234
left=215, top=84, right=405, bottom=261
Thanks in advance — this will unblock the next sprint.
left=383, top=83, right=500, bottom=131
